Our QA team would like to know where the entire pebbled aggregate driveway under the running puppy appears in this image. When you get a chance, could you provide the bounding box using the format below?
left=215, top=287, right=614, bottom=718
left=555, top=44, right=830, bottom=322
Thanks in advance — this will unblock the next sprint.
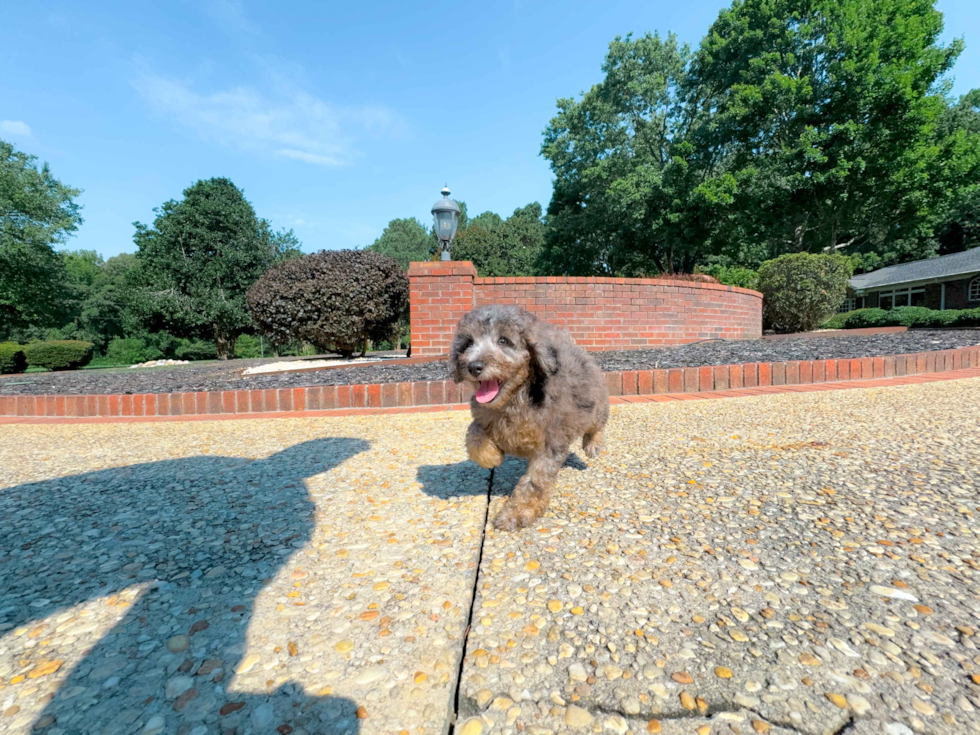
left=0, top=379, right=980, bottom=735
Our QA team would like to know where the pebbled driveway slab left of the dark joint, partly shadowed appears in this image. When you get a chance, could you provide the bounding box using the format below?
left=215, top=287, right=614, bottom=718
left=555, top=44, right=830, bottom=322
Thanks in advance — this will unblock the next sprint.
left=0, top=414, right=488, bottom=735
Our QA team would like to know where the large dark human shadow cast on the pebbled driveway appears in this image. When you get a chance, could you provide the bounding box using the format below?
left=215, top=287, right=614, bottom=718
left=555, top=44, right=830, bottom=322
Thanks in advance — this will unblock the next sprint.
left=0, top=438, right=369, bottom=735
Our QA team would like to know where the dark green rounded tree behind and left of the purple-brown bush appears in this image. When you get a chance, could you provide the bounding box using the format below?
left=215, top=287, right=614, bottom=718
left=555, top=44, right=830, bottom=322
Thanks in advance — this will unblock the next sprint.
left=134, top=178, right=298, bottom=359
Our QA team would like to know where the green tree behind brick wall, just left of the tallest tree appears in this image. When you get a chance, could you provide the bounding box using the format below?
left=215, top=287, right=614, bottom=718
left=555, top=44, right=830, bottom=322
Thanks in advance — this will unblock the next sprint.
left=540, top=34, right=735, bottom=275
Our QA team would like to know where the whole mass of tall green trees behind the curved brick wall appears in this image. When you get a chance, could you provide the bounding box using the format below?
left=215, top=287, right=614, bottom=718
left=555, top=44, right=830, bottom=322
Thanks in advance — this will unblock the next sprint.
left=542, top=0, right=980, bottom=275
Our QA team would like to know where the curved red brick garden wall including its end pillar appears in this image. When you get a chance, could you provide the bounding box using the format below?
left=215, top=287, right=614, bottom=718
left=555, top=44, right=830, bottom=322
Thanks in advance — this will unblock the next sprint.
left=408, top=261, right=762, bottom=356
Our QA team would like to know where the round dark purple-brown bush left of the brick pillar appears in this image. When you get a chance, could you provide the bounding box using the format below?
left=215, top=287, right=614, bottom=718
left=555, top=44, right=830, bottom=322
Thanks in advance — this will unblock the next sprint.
left=248, top=250, right=408, bottom=357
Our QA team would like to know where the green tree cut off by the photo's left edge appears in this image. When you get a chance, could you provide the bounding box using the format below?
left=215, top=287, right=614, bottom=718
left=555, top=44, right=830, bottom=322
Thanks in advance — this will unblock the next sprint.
left=0, top=140, right=82, bottom=338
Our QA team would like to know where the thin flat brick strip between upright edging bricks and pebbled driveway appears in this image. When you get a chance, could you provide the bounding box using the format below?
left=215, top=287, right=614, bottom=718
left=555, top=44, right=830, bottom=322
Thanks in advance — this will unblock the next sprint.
left=0, top=367, right=980, bottom=425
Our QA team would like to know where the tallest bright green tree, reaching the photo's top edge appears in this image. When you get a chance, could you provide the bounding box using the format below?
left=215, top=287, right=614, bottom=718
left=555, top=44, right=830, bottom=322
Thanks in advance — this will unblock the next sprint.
left=685, top=0, right=965, bottom=265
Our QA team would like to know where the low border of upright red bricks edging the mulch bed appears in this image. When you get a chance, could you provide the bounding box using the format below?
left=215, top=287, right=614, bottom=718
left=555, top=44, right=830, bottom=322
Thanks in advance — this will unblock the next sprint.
left=0, top=346, right=980, bottom=418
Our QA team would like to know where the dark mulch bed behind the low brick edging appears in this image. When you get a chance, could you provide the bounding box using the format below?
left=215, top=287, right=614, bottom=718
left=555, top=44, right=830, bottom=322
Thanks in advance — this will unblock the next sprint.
left=0, top=329, right=980, bottom=395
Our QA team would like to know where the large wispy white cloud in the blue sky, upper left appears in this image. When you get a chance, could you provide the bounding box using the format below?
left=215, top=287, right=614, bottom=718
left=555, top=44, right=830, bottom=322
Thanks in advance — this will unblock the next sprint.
left=133, top=67, right=399, bottom=166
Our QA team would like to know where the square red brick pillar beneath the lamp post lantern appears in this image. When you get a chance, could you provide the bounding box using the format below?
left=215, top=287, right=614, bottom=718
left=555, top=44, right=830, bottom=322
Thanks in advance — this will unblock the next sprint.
left=408, top=260, right=476, bottom=357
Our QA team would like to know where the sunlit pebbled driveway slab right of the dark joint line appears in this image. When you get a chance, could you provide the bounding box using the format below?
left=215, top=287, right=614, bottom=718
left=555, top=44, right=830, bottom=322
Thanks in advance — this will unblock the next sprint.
left=460, top=380, right=980, bottom=735
